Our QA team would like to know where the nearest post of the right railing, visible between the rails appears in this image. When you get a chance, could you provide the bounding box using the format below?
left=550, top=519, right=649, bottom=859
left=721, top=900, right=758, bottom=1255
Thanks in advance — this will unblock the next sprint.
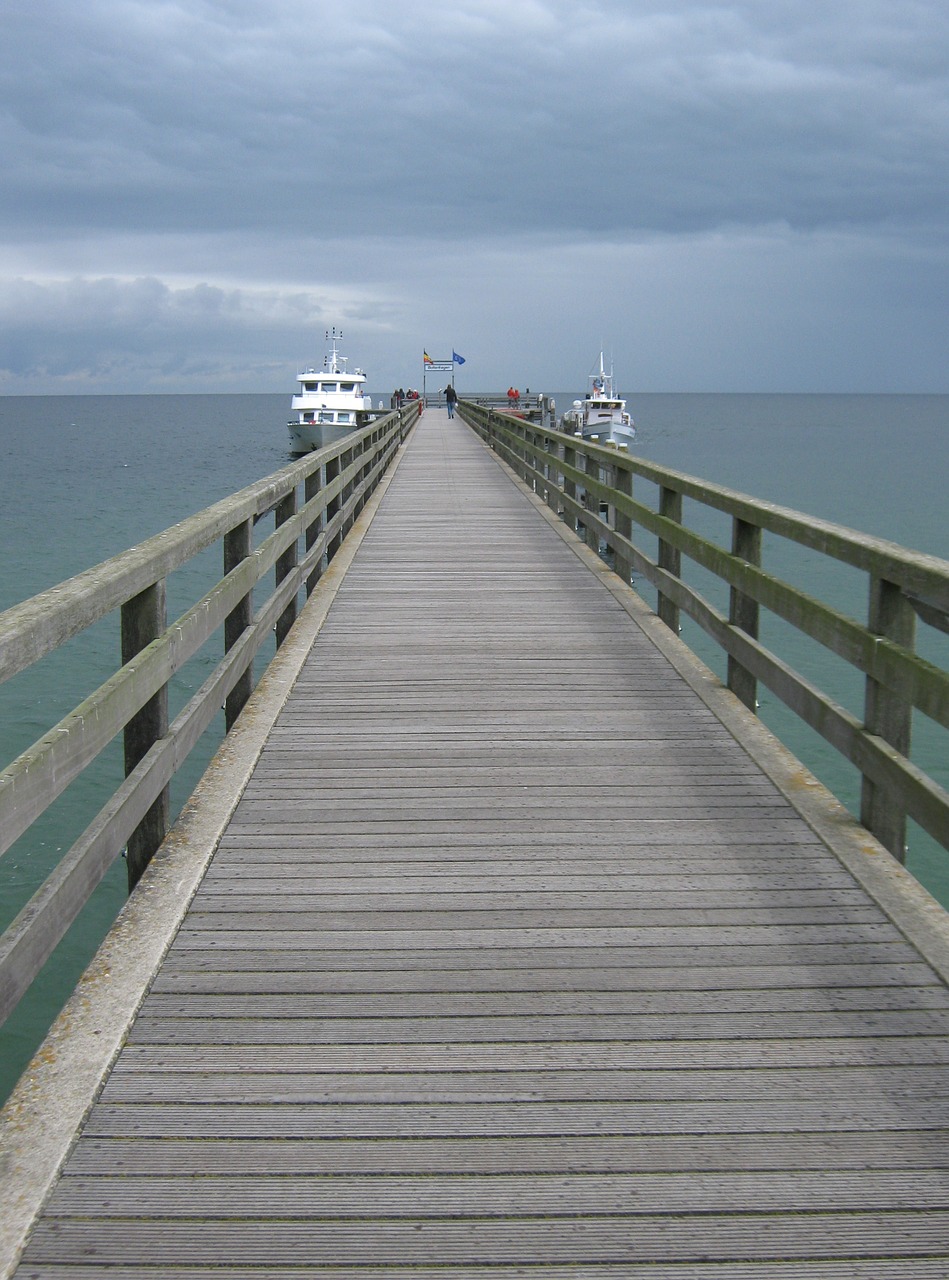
left=861, top=576, right=916, bottom=861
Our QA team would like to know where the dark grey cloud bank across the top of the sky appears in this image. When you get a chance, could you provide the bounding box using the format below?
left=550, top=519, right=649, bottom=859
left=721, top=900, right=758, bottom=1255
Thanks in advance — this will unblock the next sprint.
left=4, top=0, right=949, bottom=234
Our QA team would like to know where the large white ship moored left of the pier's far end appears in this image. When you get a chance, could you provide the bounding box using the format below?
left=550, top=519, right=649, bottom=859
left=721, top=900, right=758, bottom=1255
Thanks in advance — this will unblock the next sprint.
left=287, top=329, right=373, bottom=454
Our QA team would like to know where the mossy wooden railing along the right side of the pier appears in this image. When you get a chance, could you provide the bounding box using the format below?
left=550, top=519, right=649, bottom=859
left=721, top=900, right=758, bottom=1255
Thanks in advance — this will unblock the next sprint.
left=458, top=401, right=949, bottom=860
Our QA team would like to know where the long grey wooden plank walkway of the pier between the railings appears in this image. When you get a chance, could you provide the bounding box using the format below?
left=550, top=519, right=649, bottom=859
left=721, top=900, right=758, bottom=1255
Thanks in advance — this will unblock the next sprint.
left=9, top=411, right=949, bottom=1280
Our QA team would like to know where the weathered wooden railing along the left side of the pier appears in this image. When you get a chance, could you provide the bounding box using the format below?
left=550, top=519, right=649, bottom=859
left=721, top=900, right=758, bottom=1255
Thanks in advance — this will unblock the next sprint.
left=0, top=403, right=419, bottom=1021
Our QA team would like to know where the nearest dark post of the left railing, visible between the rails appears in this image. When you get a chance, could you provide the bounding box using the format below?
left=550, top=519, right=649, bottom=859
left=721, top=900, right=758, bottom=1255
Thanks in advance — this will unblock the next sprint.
left=122, top=579, right=172, bottom=892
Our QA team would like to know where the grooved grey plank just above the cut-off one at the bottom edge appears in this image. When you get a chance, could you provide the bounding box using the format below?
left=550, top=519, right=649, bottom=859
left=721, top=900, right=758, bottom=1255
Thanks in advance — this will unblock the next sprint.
left=20, top=1211, right=949, bottom=1277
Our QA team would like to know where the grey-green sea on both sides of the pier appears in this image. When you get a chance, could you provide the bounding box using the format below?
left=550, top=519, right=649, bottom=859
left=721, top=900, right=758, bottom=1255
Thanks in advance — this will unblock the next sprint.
left=0, top=388, right=949, bottom=1100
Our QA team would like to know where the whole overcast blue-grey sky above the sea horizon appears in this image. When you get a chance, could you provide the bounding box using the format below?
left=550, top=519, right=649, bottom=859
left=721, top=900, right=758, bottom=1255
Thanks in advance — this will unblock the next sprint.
left=0, top=0, right=949, bottom=394
